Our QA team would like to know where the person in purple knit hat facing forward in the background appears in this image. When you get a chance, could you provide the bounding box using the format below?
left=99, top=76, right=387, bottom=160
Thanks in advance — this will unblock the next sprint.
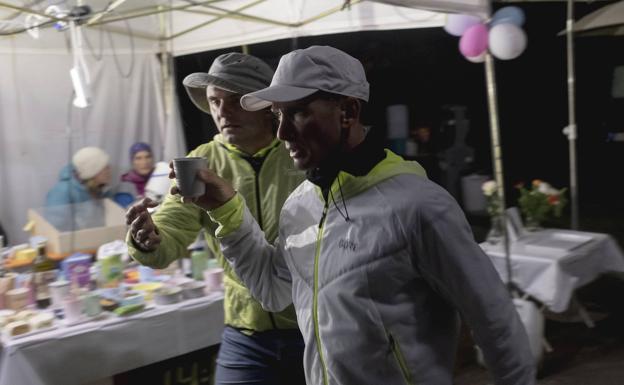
left=119, top=142, right=154, bottom=198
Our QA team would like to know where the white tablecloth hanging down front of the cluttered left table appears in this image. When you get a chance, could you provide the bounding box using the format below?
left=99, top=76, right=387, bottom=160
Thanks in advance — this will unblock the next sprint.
left=0, top=293, right=223, bottom=385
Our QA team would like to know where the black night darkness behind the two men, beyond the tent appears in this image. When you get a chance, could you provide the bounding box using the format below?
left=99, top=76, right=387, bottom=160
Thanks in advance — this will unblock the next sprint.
left=175, top=2, right=624, bottom=230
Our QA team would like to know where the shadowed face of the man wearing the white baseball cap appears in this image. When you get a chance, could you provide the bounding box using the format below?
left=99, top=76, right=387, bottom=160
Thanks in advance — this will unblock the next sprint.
left=272, top=95, right=342, bottom=170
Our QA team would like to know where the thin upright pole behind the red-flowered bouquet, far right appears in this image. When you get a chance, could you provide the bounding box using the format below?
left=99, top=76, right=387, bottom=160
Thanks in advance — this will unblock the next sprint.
left=564, top=0, right=579, bottom=230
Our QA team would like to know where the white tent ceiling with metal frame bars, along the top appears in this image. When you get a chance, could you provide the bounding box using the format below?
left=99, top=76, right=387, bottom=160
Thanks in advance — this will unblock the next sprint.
left=0, top=0, right=489, bottom=55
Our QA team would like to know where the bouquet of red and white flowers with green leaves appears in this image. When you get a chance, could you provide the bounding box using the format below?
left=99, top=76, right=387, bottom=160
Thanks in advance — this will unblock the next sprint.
left=516, top=179, right=568, bottom=229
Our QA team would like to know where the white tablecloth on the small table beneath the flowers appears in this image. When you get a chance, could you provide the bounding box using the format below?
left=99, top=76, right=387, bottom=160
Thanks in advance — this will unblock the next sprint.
left=481, top=229, right=624, bottom=313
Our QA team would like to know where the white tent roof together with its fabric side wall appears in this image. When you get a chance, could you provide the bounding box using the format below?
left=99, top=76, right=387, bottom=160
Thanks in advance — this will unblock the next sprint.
left=0, top=0, right=489, bottom=243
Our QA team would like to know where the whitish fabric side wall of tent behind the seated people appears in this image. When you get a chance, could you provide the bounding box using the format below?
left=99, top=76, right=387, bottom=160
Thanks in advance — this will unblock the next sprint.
left=0, top=48, right=185, bottom=244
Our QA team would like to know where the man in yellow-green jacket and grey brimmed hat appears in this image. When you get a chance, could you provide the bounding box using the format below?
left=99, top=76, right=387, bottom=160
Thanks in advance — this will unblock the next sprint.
left=127, top=53, right=305, bottom=385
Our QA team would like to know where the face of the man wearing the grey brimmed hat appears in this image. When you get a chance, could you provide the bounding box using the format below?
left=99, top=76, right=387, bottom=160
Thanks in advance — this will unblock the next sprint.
left=206, top=86, right=273, bottom=153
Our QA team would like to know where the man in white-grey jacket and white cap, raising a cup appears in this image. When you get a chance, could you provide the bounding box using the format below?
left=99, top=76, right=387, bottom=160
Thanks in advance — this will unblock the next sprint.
left=171, top=46, right=535, bottom=385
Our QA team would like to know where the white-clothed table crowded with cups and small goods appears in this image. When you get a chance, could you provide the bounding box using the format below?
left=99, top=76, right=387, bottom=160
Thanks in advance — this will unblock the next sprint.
left=0, top=237, right=228, bottom=385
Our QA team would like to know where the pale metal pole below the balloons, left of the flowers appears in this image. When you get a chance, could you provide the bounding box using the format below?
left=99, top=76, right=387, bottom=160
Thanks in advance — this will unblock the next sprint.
left=485, top=52, right=515, bottom=292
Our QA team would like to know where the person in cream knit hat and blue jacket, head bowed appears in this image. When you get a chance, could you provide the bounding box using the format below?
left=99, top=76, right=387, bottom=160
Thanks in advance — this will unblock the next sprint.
left=45, top=147, right=112, bottom=206
